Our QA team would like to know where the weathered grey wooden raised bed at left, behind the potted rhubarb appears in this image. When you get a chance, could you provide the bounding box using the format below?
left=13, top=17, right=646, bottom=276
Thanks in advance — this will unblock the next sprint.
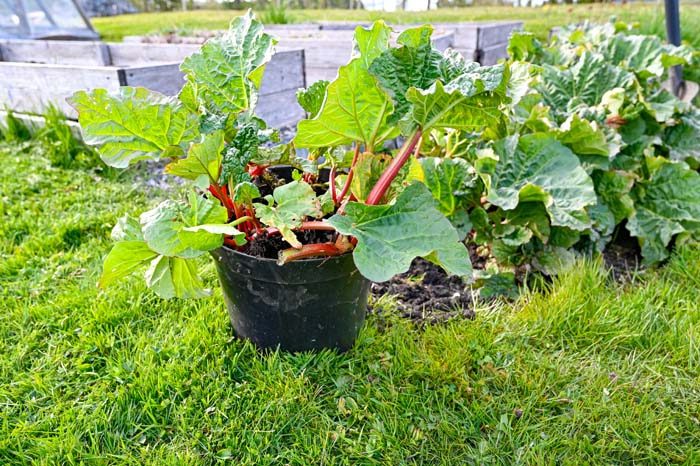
left=0, top=39, right=306, bottom=126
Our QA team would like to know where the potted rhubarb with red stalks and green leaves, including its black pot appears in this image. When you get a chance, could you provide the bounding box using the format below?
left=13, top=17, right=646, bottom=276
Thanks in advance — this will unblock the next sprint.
left=70, top=13, right=509, bottom=351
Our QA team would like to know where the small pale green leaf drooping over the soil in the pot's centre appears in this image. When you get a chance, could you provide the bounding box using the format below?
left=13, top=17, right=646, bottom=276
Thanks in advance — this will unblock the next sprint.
left=253, top=181, right=322, bottom=248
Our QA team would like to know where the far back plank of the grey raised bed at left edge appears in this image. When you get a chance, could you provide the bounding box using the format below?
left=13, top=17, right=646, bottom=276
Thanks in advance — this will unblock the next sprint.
left=0, top=39, right=110, bottom=66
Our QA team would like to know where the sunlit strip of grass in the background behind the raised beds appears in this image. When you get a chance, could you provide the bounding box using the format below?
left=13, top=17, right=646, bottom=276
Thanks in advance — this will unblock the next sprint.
left=92, top=2, right=700, bottom=48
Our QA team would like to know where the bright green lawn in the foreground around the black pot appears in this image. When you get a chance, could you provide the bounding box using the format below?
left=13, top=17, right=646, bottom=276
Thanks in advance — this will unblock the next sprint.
left=0, top=138, right=700, bottom=465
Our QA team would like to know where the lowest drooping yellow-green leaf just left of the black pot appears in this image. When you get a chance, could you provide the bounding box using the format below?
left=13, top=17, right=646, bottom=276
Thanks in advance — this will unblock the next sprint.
left=144, top=256, right=211, bottom=299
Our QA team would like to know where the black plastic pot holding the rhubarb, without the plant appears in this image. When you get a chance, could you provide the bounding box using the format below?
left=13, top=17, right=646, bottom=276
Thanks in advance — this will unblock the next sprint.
left=212, top=246, right=370, bottom=351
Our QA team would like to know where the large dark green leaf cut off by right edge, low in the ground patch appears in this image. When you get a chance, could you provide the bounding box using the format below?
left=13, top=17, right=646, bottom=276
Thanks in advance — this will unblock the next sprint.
left=627, top=161, right=700, bottom=263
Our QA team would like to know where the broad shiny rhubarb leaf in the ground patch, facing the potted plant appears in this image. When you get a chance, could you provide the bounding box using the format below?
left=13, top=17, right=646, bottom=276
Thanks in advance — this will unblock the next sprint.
left=477, top=134, right=596, bottom=230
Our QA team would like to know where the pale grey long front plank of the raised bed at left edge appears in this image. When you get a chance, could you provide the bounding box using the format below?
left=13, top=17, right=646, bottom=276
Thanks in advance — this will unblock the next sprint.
left=0, top=62, right=120, bottom=118
